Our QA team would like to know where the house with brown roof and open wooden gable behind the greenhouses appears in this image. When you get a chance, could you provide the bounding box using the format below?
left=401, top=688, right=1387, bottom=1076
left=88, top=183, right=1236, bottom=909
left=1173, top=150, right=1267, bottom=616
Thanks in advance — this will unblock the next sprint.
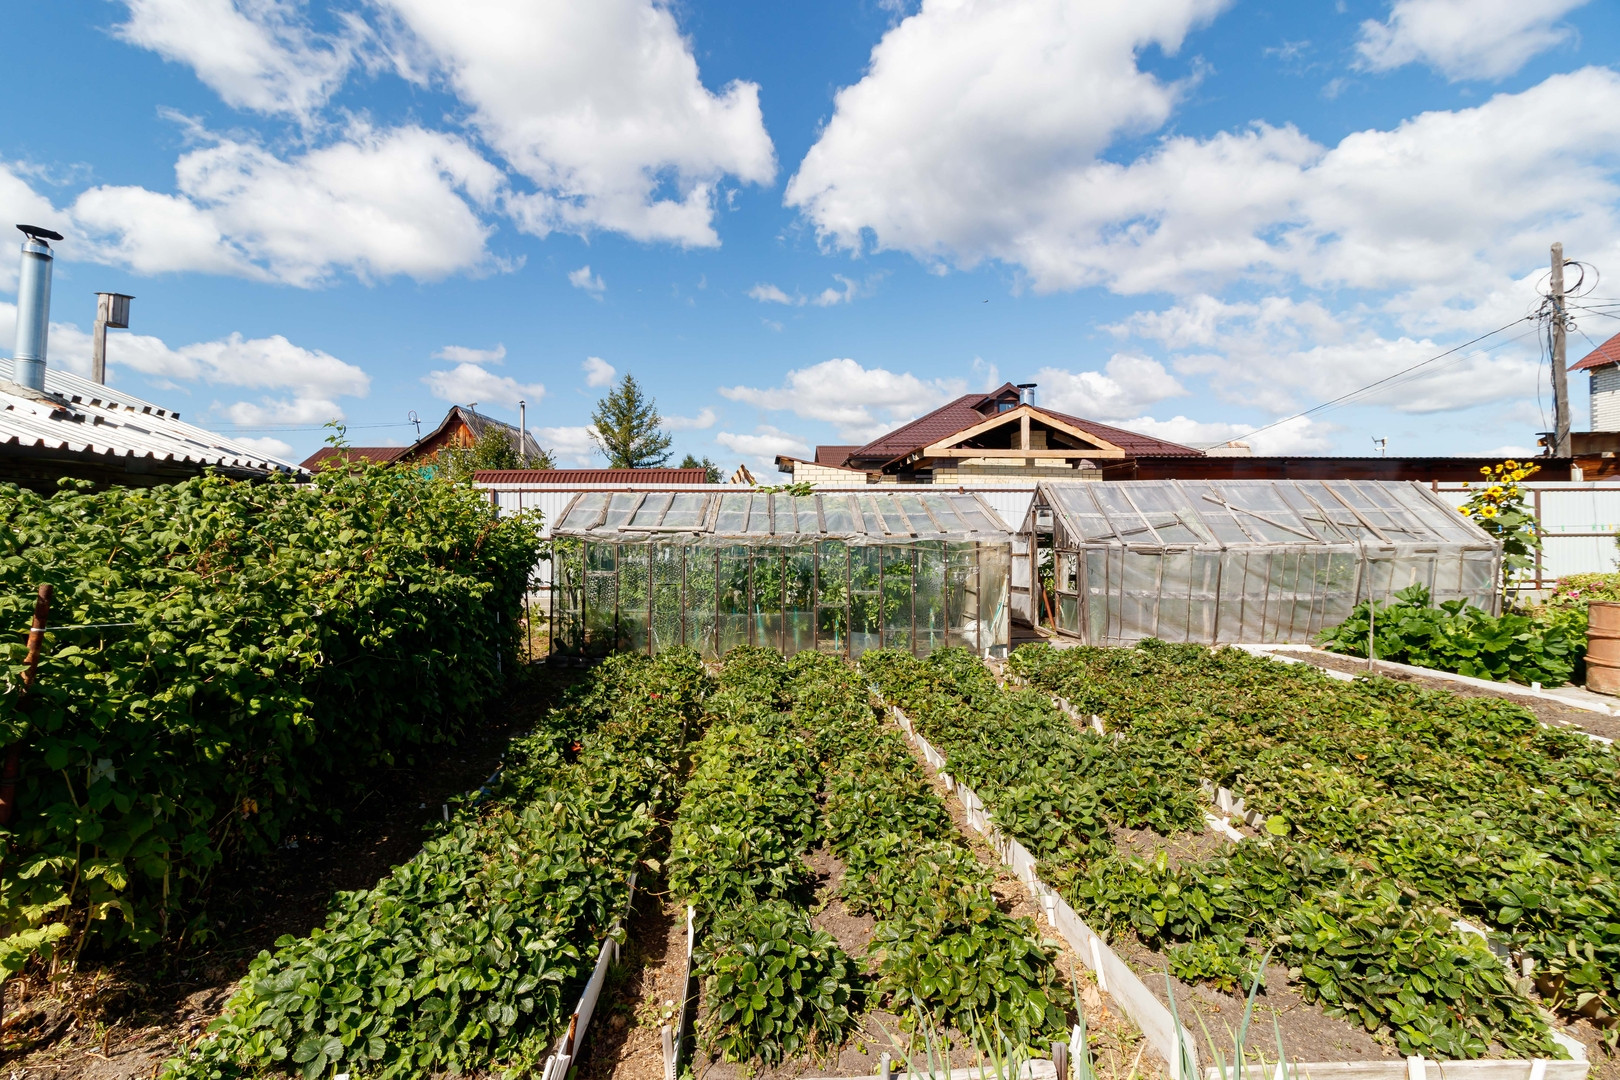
left=776, top=382, right=1204, bottom=484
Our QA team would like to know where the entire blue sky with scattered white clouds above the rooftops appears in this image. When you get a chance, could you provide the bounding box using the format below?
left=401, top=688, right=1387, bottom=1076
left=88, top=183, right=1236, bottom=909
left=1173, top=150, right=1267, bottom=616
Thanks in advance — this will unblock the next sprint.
left=0, top=0, right=1620, bottom=468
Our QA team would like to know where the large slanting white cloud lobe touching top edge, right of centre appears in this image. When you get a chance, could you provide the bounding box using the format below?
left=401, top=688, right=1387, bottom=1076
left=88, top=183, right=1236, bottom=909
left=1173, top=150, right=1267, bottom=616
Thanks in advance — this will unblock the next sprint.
left=787, top=0, right=1225, bottom=275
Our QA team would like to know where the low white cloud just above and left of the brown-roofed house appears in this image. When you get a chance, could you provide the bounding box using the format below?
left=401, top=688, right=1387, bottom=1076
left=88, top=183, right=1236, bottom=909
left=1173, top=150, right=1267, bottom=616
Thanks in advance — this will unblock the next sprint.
left=716, top=359, right=967, bottom=440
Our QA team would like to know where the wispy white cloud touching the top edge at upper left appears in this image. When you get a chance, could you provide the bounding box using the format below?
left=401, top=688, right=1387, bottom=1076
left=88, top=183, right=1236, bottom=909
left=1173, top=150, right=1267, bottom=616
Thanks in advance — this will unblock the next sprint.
left=113, top=0, right=368, bottom=120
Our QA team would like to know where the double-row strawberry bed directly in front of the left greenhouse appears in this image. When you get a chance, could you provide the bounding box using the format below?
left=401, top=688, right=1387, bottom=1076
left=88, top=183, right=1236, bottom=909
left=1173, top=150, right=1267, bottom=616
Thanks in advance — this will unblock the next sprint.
left=669, top=649, right=1129, bottom=1077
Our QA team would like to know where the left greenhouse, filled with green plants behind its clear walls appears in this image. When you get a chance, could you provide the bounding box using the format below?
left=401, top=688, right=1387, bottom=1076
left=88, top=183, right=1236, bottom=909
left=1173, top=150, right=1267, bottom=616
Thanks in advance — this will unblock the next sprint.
left=552, top=491, right=1011, bottom=657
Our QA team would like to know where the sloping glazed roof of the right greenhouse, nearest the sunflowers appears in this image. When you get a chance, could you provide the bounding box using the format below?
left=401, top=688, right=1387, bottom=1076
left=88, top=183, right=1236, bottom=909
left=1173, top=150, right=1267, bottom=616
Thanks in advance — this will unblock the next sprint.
left=1030, top=479, right=1495, bottom=547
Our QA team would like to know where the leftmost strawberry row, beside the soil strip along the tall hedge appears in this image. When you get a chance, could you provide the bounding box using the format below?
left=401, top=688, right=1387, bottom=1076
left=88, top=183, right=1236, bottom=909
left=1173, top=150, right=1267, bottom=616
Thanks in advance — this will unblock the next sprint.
left=165, top=651, right=703, bottom=1080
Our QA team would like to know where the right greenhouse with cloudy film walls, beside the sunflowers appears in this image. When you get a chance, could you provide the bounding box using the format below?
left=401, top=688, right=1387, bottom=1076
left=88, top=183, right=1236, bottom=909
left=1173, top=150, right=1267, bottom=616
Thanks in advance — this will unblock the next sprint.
left=1017, top=479, right=1502, bottom=644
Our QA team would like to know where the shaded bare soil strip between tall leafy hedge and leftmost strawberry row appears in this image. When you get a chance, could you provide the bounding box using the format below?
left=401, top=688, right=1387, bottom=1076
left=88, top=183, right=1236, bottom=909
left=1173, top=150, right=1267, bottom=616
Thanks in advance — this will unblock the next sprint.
left=0, top=669, right=576, bottom=1080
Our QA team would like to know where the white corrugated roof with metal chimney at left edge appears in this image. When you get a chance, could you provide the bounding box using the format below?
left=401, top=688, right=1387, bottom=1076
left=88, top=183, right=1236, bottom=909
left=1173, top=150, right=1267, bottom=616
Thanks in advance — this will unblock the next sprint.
left=0, top=356, right=303, bottom=473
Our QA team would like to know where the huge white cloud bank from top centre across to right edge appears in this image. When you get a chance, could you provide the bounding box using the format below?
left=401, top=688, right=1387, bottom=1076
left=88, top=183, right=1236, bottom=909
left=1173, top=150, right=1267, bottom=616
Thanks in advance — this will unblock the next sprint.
left=787, top=9, right=1620, bottom=306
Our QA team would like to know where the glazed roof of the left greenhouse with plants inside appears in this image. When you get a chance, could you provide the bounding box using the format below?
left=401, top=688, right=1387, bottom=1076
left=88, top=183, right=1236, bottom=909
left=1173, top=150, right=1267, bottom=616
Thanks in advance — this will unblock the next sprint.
left=551, top=491, right=1009, bottom=544
